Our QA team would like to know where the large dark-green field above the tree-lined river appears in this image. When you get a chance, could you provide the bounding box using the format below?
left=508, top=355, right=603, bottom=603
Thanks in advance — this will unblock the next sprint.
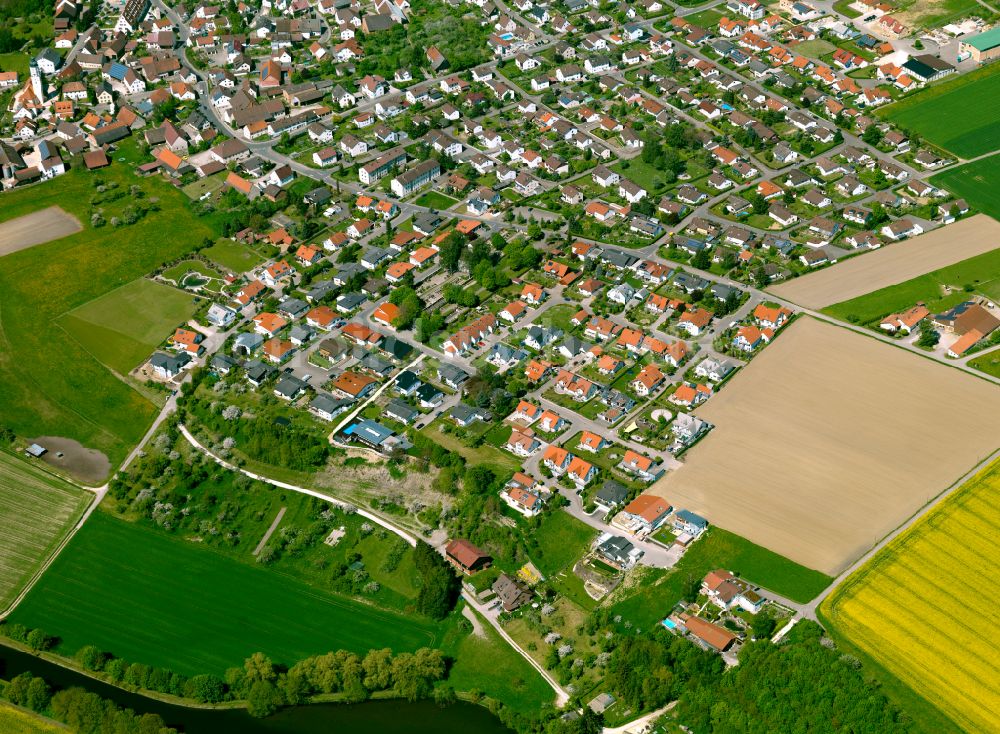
left=11, top=513, right=441, bottom=675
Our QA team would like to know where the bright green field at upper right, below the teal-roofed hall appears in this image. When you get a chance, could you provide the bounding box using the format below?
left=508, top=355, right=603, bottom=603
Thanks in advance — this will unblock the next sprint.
left=879, top=65, right=1000, bottom=158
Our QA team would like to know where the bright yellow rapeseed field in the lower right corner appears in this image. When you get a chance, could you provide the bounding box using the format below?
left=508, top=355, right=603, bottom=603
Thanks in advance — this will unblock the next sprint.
left=820, top=462, right=1000, bottom=732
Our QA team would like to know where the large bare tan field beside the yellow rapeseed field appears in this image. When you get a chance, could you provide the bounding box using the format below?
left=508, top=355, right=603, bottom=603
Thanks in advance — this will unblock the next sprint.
left=652, top=318, right=1000, bottom=576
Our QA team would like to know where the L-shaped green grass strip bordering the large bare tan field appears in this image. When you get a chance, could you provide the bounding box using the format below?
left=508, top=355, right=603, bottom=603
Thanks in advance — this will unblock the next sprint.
left=612, top=528, right=833, bottom=629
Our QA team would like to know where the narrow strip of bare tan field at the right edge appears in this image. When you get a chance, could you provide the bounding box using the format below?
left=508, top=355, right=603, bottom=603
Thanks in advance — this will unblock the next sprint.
left=768, top=214, right=1000, bottom=309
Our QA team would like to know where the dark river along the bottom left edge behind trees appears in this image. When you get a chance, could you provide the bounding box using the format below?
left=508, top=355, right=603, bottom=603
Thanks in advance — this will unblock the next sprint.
left=0, top=645, right=510, bottom=734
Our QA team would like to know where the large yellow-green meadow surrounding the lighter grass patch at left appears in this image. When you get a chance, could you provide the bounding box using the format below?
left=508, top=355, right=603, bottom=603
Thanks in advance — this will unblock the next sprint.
left=0, top=144, right=216, bottom=466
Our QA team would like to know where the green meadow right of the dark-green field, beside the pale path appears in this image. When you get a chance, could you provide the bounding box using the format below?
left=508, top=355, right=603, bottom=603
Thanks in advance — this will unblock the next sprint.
left=441, top=617, right=555, bottom=714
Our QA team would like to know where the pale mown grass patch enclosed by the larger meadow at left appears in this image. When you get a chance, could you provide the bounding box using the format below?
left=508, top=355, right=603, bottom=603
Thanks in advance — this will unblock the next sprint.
left=59, top=278, right=196, bottom=375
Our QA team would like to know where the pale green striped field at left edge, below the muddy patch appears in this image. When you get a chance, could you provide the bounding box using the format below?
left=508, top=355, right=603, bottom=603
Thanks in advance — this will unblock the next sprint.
left=0, top=452, right=90, bottom=611
